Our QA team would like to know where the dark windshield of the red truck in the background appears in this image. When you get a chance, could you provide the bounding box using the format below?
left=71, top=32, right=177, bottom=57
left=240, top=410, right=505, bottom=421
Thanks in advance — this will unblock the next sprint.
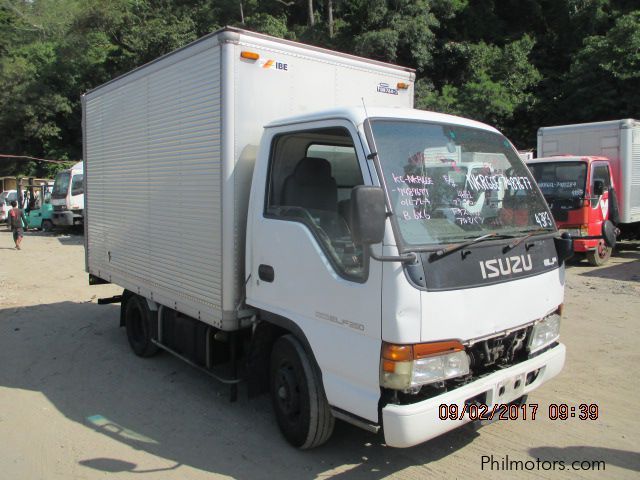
left=529, top=162, right=587, bottom=210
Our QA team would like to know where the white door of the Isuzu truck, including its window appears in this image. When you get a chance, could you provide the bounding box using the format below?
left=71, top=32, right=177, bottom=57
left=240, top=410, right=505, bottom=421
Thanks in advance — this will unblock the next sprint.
left=247, top=121, right=382, bottom=421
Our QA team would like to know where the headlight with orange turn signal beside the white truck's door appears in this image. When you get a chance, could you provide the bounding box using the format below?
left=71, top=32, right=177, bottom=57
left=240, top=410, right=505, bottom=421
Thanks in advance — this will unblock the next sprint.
left=380, top=342, right=469, bottom=390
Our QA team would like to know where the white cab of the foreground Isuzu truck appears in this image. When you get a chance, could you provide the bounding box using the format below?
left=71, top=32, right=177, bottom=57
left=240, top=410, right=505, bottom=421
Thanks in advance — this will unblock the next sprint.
left=245, top=108, right=565, bottom=447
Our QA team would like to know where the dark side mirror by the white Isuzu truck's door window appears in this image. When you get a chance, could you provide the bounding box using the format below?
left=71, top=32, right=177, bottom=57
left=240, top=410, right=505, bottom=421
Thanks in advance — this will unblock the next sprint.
left=351, top=185, right=386, bottom=245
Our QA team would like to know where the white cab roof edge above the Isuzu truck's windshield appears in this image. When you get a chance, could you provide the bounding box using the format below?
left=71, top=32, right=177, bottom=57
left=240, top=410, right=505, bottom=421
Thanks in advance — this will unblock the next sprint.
left=265, top=106, right=500, bottom=133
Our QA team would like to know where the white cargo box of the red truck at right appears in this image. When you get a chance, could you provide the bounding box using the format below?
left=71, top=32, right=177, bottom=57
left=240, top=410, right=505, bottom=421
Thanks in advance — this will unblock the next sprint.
left=538, top=119, right=640, bottom=223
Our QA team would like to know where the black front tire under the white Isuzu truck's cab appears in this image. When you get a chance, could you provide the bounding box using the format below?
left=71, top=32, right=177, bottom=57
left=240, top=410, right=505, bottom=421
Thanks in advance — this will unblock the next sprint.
left=269, top=335, right=335, bottom=450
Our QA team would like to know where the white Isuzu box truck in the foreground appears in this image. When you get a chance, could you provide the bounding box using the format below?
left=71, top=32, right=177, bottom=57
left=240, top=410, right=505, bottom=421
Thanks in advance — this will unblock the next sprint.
left=83, top=28, right=572, bottom=448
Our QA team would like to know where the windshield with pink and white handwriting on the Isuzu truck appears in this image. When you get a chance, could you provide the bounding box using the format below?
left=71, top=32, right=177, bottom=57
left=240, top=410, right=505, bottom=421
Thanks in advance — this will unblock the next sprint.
left=372, top=120, right=555, bottom=246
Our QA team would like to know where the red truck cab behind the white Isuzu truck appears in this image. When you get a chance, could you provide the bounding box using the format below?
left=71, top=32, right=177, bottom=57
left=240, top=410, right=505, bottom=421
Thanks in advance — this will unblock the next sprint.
left=527, top=155, right=615, bottom=266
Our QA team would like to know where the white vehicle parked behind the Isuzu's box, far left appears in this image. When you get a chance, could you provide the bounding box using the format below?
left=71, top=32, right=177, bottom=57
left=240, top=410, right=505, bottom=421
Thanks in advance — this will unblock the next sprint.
left=51, top=162, right=84, bottom=227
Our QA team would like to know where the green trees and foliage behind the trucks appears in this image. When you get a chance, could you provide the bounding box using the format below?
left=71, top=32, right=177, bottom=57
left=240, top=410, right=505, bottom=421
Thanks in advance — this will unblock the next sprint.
left=0, top=0, right=640, bottom=176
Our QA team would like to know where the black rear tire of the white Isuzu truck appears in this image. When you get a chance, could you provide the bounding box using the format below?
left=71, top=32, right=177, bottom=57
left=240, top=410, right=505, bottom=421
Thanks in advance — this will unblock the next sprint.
left=122, top=295, right=159, bottom=357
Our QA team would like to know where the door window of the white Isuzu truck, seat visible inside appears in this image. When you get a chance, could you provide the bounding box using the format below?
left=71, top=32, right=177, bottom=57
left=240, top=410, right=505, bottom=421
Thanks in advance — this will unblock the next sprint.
left=265, top=128, right=366, bottom=281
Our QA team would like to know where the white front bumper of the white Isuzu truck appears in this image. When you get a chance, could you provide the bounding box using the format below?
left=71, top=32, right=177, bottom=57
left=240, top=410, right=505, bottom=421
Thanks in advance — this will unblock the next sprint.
left=382, top=344, right=566, bottom=448
